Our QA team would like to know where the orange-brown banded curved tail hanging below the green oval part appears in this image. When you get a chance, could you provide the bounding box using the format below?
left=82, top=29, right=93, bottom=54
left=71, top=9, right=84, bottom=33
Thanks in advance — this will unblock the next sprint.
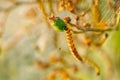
left=65, top=28, right=100, bottom=75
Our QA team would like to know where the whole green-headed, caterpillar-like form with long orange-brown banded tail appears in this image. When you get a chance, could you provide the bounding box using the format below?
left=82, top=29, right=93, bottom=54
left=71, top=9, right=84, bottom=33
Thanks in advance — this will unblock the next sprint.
left=49, top=16, right=100, bottom=75
